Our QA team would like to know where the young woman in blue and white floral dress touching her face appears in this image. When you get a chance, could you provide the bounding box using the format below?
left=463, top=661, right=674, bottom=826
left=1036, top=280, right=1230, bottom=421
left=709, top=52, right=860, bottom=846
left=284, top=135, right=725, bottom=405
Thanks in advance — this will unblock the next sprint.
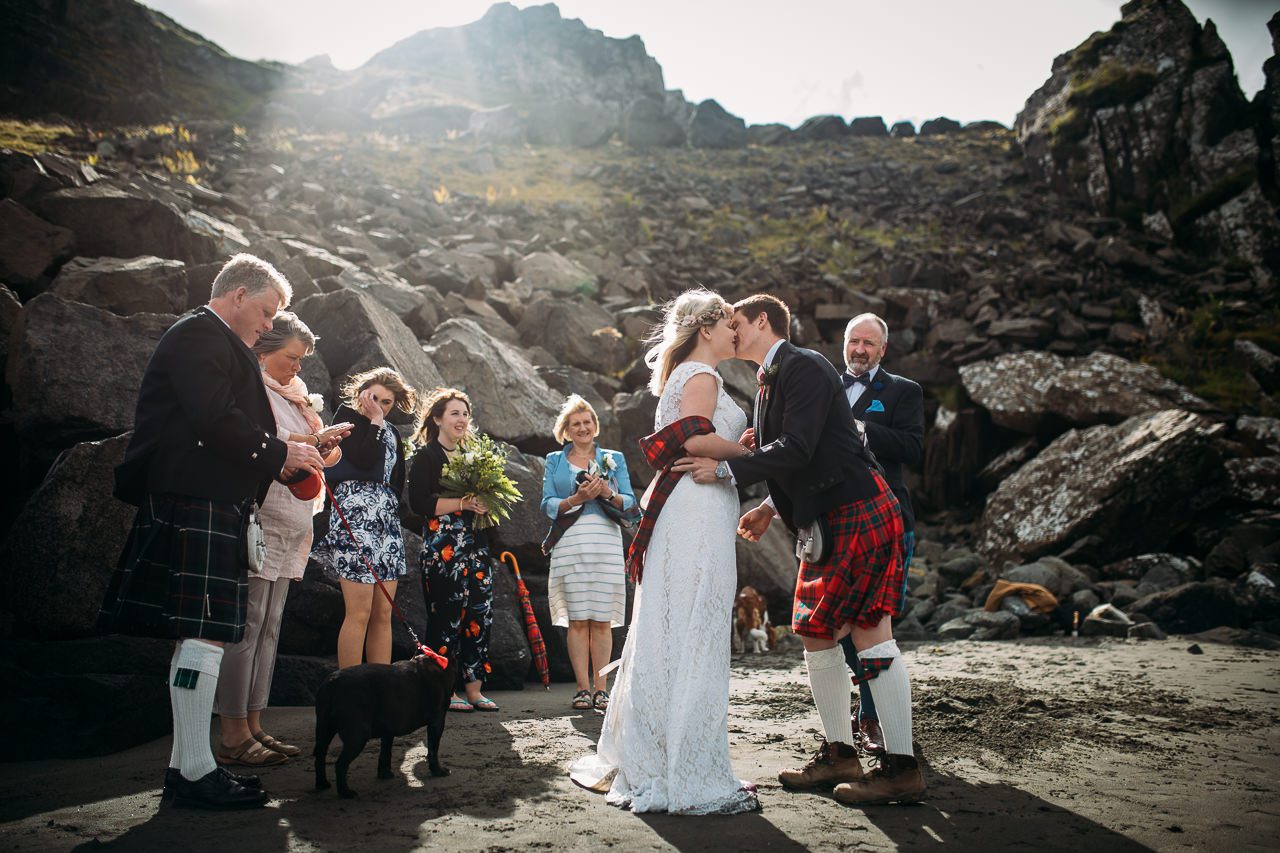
left=312, top=368, right=417, bottom=669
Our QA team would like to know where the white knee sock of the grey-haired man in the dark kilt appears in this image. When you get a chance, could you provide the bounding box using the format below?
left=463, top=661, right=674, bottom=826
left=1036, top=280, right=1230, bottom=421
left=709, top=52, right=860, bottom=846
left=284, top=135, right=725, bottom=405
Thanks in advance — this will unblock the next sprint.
left=169, top=639, right=223, bottom=781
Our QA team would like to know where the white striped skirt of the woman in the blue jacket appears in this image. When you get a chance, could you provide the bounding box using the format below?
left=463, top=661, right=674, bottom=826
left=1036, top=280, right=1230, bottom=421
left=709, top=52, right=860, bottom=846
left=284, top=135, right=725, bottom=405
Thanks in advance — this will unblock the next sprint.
left=547, top=514, right=627, bottom=628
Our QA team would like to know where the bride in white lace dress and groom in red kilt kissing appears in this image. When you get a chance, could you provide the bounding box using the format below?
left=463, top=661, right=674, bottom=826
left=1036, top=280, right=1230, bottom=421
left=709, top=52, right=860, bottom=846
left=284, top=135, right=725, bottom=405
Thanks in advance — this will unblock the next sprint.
left=570, top=289, right=924, bottom=815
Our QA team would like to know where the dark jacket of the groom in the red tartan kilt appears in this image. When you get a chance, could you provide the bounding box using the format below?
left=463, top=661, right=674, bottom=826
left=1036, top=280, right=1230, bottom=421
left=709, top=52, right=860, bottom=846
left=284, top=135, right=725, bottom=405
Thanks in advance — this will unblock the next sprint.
left=728, top=341, right=879, bottom=532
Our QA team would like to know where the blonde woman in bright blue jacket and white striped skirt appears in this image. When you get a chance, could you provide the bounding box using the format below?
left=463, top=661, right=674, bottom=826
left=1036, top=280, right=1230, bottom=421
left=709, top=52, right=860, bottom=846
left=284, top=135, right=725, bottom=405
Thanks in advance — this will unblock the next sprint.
left=541, top=394, right=636, bottom=711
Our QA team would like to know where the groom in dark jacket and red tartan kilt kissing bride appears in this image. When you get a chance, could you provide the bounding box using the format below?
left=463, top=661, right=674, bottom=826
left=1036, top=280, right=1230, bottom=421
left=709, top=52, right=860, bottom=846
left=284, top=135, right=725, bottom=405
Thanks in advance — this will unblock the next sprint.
left=677, top=293, right=924, bottom=804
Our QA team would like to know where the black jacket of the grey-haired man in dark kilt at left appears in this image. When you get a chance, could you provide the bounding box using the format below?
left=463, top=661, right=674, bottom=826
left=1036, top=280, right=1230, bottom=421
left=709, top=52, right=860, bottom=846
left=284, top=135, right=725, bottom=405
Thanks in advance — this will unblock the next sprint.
left=115, top=307, right=288, bottom=506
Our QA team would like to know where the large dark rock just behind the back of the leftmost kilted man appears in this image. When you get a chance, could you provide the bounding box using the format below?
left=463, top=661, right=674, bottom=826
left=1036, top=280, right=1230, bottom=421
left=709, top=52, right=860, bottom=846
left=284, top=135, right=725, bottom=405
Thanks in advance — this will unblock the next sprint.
left=5, top=293, right=178, bottom=441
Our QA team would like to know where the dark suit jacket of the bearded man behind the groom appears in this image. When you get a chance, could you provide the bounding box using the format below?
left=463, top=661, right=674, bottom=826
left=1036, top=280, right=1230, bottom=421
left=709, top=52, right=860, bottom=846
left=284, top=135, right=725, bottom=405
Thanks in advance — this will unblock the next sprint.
left=852, top=368, right=924, bottom=530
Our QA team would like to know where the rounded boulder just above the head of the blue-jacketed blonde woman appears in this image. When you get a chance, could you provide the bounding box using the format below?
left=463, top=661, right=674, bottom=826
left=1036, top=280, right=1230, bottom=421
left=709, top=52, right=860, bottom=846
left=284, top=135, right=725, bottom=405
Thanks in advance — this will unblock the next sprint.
left=517, top=297, right=627, bottom=373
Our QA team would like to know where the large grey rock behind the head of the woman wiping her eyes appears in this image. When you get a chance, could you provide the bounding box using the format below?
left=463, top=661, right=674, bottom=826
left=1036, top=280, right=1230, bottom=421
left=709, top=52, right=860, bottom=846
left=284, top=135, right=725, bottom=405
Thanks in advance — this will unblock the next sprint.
left=293, top=289, right=442, bottom=392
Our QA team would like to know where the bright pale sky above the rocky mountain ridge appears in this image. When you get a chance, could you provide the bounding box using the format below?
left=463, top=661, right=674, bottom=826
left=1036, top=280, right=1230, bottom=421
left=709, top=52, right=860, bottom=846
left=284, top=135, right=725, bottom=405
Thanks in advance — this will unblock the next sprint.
left=146, top=0, right=1277, bottom=127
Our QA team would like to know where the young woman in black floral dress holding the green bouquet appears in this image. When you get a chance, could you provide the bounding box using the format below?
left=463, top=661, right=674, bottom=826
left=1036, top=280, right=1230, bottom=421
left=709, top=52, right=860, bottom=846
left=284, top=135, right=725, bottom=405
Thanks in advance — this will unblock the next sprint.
left=408, top=388, right=498, bottom=711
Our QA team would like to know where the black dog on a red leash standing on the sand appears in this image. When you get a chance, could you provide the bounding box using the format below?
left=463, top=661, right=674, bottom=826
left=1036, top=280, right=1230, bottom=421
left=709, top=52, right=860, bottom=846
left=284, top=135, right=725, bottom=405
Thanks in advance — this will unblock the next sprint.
left=315, top=654, right=454, bottom=797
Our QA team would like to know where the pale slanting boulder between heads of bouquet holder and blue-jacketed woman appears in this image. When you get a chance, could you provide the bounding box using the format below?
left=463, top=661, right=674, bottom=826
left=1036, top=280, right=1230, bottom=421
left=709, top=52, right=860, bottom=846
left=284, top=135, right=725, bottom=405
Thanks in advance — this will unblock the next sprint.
left=426, top=319, right=559, bottom=452
